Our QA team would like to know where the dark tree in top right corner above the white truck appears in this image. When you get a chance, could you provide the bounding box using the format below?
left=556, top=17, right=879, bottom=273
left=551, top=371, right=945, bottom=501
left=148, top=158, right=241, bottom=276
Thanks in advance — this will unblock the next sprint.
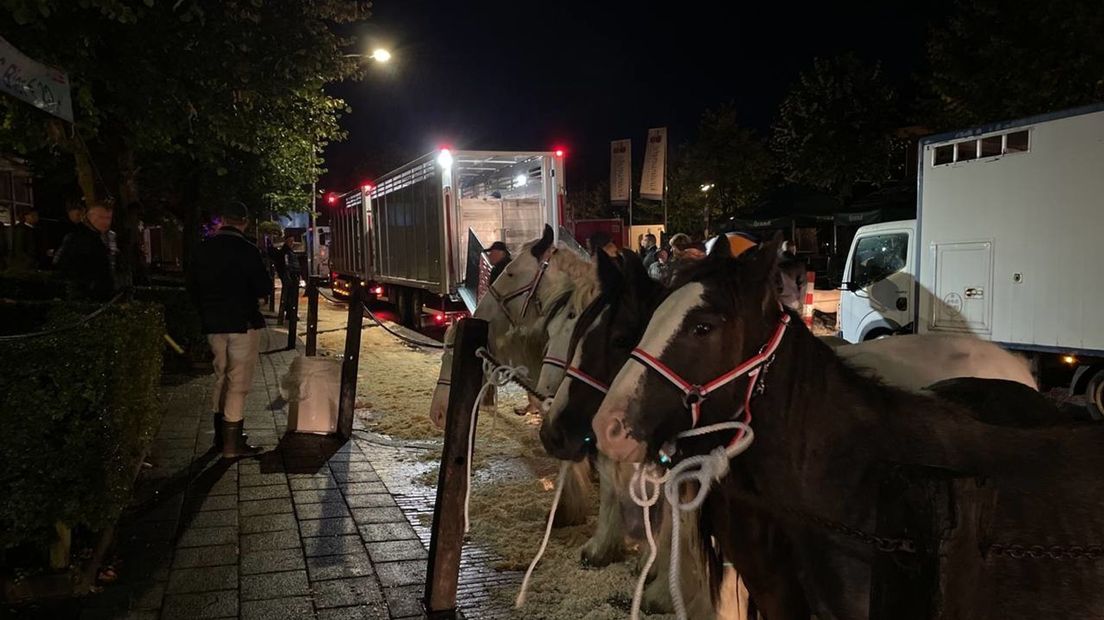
left=926, top=0, right=1104, bottom=129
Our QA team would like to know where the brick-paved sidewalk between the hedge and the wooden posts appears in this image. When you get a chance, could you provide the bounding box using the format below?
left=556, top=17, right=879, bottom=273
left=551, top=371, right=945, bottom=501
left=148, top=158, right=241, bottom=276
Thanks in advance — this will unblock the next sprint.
left=70, top=328, right=432, bottom=620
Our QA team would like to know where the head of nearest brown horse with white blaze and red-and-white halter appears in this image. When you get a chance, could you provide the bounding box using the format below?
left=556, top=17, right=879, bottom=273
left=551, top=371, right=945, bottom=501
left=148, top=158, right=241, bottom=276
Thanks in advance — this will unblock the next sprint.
left=592, top=233, right=783, bottom=462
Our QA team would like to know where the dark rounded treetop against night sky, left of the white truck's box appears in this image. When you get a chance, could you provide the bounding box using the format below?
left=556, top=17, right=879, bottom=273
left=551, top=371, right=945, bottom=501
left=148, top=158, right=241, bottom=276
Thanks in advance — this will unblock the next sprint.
left=771, top=54, right=905, bottom=200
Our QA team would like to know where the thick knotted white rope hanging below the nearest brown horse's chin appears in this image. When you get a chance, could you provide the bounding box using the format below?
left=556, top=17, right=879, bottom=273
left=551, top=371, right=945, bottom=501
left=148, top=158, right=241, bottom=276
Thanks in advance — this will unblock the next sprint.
left=629, top=421, right=755, bottom=620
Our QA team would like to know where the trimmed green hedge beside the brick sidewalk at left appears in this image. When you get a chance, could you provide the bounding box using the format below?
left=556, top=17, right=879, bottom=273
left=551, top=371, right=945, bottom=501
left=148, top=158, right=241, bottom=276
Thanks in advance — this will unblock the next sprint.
left=0, top=302, right=164, bottom=549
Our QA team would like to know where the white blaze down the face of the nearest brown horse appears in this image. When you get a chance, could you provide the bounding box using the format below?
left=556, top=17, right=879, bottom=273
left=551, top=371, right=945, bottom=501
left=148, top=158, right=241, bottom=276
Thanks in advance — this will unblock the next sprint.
left=593, top=282, right=705, bottom=461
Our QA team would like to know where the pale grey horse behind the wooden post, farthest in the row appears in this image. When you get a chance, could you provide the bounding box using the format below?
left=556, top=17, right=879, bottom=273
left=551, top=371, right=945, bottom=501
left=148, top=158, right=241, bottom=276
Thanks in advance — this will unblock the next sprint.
left=429, top=226, right=594, bottom=525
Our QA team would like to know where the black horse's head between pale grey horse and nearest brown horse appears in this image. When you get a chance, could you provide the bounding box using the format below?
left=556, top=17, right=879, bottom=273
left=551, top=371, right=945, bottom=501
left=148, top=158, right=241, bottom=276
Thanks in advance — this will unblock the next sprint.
left=541, top=247, right=662, bottom=460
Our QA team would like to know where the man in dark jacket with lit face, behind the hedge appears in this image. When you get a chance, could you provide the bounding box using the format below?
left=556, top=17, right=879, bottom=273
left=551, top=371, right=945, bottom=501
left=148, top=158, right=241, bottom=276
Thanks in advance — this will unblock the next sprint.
left=54, top=203, right=116, bottom=301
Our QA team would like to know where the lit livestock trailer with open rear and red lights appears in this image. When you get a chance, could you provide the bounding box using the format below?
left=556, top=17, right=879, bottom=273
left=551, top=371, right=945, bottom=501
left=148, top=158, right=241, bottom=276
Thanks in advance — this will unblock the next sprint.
left=330, top=149, right=564, bottom=327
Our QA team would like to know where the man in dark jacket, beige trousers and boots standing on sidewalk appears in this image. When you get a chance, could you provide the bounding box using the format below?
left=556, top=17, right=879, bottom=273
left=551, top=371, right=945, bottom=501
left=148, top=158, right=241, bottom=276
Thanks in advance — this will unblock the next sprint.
left=188, top=202, right=272, bottom=459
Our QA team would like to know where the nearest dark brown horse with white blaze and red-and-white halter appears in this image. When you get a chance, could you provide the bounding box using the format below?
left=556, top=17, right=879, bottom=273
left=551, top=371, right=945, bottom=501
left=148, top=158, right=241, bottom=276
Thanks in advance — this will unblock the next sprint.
left=592, top=233, right=1104, bottom=619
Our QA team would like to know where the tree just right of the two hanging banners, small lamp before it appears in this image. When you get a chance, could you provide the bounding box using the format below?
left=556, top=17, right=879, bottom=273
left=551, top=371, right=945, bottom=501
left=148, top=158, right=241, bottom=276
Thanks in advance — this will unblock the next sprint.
left=668, top=104, right=775, bottom=232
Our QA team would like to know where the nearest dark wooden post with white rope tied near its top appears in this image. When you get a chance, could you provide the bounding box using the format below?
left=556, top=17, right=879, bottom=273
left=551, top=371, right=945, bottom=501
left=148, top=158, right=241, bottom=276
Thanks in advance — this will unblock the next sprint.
left=424, top=319, right=488, bottom=618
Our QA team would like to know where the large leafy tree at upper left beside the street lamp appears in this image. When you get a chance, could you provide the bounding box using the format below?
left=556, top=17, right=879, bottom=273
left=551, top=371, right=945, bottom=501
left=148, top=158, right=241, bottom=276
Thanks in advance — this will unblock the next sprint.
left=0, top=0, right=371, bottom=268
